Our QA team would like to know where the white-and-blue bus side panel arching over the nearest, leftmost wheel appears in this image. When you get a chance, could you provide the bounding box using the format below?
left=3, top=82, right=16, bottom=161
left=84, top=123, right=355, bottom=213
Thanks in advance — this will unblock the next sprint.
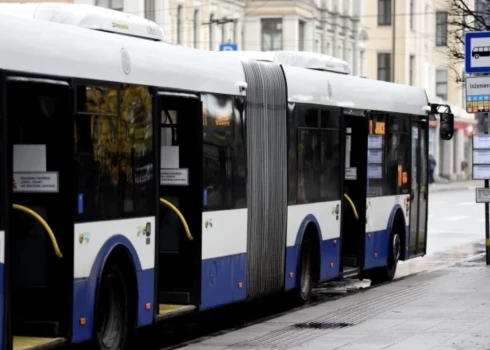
left=72, top=217, right=155, bottom=343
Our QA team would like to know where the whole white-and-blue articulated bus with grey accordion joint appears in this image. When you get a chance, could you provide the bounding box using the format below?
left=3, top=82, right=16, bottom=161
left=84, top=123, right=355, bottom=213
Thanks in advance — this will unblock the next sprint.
left=0, top=4, right=453, bottom=350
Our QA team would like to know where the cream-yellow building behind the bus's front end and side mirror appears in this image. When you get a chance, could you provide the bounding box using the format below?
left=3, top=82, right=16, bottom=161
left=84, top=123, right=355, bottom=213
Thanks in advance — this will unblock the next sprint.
left=361, top=0, right=476, bottom=180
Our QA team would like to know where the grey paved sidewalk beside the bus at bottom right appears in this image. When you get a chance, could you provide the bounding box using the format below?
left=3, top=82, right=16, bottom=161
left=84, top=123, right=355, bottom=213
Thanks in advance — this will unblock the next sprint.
left=182, top=256, right=490, bottom=350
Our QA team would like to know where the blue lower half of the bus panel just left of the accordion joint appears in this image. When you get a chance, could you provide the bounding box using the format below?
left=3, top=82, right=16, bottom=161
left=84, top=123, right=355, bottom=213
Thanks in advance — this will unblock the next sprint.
left=199, top=253, right=247, bottom=310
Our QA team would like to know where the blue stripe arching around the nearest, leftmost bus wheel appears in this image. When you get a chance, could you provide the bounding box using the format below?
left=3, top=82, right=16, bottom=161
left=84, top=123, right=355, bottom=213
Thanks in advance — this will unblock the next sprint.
left=72, top=235, right=155, bottom=343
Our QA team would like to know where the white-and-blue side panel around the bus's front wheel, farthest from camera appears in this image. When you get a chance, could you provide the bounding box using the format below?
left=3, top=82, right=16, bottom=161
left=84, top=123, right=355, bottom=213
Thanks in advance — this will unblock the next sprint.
left=364, top=194, right=409, bottom=270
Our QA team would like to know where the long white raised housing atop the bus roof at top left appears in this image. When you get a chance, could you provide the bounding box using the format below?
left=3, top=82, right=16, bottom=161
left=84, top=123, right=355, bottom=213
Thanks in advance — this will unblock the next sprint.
left=0, top=3, right=164, bottom=41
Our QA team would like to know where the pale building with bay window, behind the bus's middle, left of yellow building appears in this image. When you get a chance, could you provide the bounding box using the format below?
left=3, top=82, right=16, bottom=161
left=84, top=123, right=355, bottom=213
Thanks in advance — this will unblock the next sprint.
left=241, top=0, right=363, bottom=74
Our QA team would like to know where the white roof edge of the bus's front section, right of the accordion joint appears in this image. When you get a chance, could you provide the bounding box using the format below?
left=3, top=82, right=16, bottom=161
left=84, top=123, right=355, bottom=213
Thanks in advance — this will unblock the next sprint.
left=283, top=66, right=429, bottom=115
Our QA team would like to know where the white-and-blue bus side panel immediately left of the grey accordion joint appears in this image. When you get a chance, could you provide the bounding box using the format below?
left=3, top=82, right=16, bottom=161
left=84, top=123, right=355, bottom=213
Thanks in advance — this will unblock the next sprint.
left=200, top=209, right=248, bottom=310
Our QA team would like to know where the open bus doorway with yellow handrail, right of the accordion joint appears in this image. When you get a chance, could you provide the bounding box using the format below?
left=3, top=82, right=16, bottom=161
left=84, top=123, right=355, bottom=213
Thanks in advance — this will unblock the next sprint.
left=341, top=110, right=368, bottom=277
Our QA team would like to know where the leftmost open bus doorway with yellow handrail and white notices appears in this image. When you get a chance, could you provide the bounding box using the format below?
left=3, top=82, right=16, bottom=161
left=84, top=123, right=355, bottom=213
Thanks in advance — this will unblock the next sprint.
left=2, top=76, right=74, bottom=349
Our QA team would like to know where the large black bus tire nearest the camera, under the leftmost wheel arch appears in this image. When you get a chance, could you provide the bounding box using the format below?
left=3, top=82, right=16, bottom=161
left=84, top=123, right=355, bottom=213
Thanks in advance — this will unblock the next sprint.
left=94, top=264, right=131, bottom=350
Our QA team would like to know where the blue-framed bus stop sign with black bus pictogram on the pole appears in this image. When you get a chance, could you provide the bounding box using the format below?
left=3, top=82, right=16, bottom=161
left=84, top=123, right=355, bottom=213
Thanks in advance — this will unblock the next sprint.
left=464, top=32, right=490, bottom=73
